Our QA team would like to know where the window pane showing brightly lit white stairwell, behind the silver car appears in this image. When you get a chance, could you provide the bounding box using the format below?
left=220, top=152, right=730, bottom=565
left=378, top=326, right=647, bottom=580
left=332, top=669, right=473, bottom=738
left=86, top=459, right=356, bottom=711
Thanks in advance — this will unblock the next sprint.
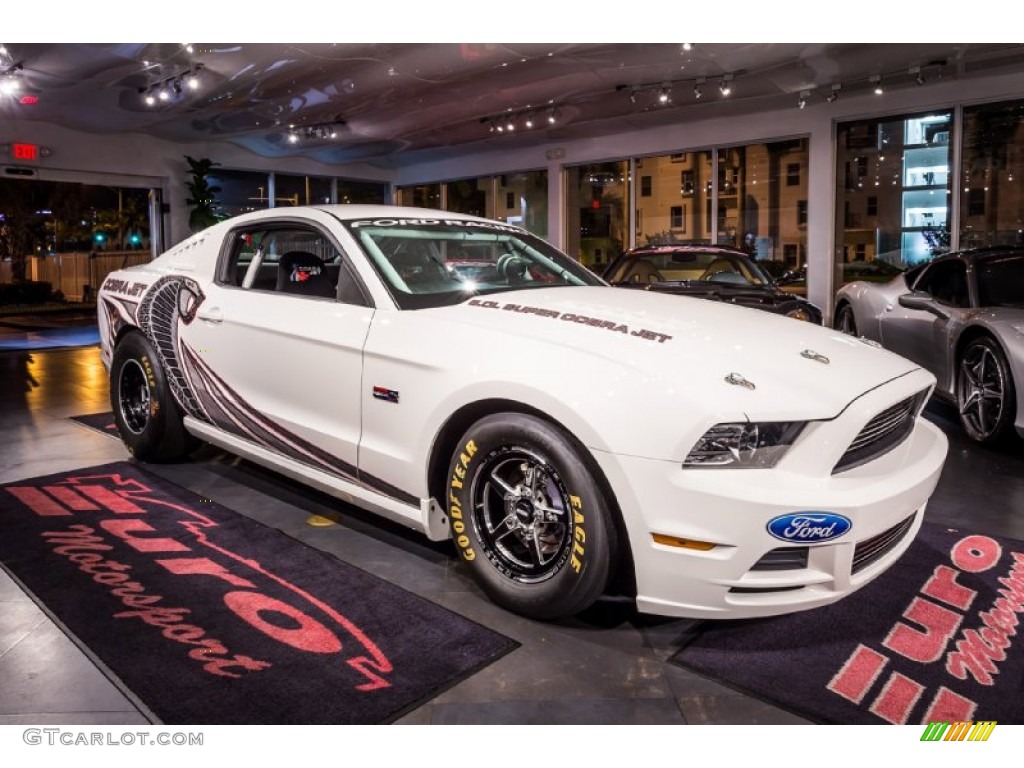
left=836, top=111, right=952, bottom=288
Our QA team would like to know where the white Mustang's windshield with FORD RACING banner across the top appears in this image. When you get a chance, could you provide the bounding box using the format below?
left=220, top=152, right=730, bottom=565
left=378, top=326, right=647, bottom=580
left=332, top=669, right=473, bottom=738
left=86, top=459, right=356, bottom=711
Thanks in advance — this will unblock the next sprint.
left=342, top=218, right=605, bottom=309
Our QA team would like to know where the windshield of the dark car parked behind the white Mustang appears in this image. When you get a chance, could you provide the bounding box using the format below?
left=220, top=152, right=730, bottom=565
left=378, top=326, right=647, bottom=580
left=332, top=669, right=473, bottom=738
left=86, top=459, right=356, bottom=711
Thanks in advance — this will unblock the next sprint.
left=608, top=249, right=772, bottom=286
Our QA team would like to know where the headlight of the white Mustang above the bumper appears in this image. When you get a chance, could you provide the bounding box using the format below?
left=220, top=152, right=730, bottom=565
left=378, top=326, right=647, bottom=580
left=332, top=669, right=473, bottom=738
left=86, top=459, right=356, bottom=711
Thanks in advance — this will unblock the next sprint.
left=683, top=421, right=807, bottom=469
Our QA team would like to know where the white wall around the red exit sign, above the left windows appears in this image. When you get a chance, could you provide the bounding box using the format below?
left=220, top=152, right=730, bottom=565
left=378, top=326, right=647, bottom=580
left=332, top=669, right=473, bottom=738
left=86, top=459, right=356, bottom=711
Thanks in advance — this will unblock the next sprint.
left=0, top=119, right=393, bottom=247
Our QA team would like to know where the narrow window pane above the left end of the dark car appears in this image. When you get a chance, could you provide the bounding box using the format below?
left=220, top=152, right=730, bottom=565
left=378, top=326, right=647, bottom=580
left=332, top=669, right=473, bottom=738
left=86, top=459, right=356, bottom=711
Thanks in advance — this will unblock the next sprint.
left=565, top=161, right=630, bottom=272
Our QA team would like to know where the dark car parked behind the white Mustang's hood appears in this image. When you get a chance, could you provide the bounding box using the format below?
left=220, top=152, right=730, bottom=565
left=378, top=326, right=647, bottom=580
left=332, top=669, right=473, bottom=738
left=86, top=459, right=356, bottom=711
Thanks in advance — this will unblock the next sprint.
left=602, top=245, right=821, bottom=325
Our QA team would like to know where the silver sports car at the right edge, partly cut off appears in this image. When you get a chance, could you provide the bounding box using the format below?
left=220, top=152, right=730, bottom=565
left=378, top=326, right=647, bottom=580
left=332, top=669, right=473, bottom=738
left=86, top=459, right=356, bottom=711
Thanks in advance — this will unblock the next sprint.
left=834, top=247, right=1024, bottom=443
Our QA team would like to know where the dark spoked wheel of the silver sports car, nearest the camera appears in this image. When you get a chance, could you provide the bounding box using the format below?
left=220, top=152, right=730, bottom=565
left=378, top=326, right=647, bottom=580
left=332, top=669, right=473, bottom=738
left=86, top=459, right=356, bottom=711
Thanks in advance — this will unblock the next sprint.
left=956, top=336, right=1017, bottom=443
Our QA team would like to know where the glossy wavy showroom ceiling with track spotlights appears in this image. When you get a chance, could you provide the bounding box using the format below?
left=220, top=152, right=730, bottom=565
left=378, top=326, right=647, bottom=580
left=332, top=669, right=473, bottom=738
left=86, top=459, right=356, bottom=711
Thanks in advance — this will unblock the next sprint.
left=0, top=43, right=1024, bottom=168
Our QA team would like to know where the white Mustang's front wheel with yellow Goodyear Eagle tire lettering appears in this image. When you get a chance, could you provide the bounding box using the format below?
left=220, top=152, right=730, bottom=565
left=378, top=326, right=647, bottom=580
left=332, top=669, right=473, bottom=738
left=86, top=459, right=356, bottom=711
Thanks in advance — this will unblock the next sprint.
left=447, top=414, right=616, bottom=620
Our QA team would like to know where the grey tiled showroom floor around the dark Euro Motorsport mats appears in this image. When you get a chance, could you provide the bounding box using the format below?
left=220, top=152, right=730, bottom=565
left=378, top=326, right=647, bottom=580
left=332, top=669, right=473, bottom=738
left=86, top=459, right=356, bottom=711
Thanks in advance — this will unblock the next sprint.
left=0, top=346, right=1024, bottom=725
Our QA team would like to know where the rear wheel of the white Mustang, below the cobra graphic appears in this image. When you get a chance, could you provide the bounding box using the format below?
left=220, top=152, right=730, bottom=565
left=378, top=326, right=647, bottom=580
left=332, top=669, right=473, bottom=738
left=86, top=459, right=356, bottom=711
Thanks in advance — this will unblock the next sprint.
left=111, top=332, right=196, bottom=462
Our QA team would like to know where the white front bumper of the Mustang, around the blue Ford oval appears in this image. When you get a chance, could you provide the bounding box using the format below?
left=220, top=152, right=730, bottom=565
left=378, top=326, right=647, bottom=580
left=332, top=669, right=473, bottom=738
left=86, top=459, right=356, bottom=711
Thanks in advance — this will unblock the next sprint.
left=595, top=372, right=948, bottom=618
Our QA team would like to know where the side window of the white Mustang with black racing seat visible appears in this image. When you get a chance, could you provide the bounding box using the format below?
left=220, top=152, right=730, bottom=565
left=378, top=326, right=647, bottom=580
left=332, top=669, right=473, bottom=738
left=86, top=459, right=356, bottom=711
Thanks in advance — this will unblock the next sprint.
left=220, top=224, right=369, bottom=306
